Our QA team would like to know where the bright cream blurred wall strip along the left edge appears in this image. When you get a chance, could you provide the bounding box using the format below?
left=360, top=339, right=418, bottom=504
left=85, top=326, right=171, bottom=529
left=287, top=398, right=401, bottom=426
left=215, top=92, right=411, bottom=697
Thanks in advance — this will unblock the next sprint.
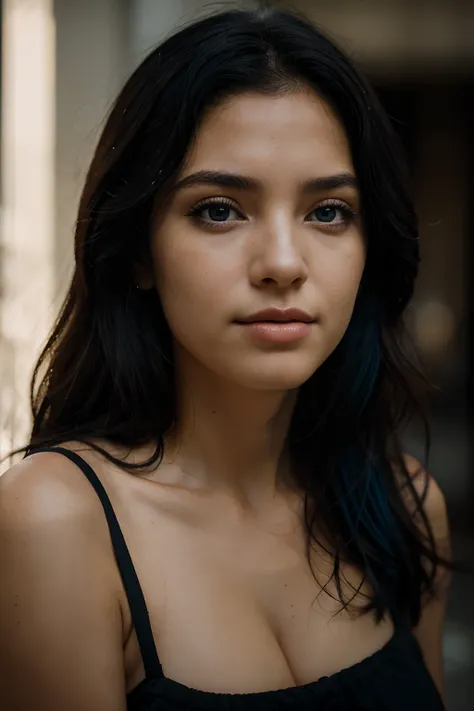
left=0, top=0, right=55, bottom=457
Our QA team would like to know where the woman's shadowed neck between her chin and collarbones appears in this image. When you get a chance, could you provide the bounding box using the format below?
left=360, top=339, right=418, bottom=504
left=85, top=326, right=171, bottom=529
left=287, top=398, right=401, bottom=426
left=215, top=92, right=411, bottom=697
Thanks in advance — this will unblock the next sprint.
left=165, top=356, right=296, bottom=506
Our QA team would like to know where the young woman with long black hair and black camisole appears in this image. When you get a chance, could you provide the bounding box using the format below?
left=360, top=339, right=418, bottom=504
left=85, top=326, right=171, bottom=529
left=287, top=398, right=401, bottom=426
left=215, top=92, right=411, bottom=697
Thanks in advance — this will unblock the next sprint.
left=0, top=6, right=450, bottom=711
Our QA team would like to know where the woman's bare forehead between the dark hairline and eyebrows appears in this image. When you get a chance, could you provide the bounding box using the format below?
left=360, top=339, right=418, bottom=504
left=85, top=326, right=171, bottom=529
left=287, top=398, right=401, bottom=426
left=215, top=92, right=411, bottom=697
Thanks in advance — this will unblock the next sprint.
left=186, top=89, right=353, bottom=175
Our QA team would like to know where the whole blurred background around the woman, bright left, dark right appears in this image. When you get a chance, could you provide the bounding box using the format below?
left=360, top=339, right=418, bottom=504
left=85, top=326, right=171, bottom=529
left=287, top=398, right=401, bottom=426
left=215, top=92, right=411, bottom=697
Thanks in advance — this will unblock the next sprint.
left=0, top=0, right=474, bottom=711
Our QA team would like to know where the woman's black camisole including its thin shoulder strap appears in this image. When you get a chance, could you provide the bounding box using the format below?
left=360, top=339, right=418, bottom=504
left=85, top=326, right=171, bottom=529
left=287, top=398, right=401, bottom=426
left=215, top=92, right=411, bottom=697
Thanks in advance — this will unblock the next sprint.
left=37, top=447, right=444, bottom=711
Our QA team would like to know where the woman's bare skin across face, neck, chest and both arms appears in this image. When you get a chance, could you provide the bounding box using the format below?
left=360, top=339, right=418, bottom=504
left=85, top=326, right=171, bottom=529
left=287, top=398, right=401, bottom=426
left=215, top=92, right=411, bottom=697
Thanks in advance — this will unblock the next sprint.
left=0, top=92, right=448, bottom=711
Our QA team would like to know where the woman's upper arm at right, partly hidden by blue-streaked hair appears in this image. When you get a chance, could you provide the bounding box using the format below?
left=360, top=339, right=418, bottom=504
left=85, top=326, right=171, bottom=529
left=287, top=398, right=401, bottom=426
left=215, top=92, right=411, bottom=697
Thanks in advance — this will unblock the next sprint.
left=406, top=458, right=451, bottom=695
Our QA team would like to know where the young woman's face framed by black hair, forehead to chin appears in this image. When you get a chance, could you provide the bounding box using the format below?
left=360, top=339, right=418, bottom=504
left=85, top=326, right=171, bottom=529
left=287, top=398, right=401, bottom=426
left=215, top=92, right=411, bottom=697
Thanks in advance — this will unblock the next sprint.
left=151, top=90, right=365, bottom=390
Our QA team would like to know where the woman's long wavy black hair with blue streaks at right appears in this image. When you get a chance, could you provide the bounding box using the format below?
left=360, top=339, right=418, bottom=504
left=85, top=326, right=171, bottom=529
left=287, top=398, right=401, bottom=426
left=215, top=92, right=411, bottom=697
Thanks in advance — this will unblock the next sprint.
left=25, top=5, right=449, bottom=624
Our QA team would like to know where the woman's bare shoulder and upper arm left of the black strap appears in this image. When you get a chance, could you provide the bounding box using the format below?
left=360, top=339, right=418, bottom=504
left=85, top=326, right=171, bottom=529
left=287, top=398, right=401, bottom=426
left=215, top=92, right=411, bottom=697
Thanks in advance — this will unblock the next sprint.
left=0, top=453, right=125, bottom=711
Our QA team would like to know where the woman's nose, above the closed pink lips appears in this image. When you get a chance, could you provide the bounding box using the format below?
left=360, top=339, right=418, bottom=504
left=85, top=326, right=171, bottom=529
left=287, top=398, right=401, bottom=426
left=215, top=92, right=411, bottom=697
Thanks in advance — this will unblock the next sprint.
left=250, top=219, right=308, bottom=289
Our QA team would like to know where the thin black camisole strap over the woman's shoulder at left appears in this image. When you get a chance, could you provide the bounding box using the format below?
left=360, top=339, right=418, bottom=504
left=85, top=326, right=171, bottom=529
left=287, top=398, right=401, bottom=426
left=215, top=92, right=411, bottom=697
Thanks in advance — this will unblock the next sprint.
left=32, top=447, right=163, bottom=678
